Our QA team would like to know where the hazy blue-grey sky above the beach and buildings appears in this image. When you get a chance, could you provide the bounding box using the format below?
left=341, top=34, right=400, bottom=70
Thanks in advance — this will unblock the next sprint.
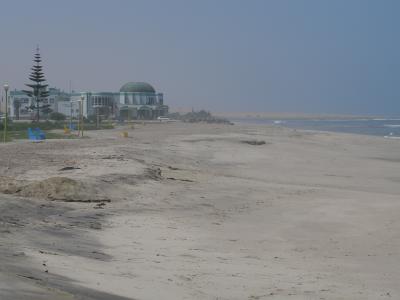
left=0, top=0, right=400, bottom=115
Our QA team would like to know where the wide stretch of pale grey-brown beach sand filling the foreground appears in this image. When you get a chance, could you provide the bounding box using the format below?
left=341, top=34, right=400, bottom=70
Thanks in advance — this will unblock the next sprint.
left=0, top=123, right=400, bottom=300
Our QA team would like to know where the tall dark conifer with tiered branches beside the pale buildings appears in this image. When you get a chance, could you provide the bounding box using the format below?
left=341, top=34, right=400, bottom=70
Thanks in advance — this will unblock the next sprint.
left=24, top=48, right=50, bottom=122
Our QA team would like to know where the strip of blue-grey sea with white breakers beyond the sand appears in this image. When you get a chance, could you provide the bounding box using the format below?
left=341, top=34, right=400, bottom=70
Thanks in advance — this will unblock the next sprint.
left=231, top=118, right=400, bottom=138
